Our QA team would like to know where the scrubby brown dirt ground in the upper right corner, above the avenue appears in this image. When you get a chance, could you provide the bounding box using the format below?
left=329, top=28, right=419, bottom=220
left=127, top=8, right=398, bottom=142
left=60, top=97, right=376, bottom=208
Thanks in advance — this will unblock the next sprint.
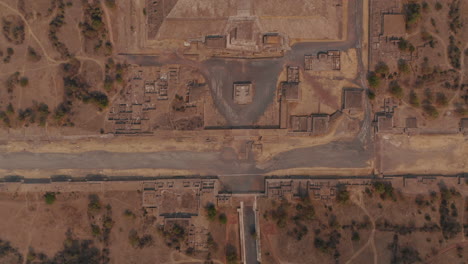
left=369, top=0, right=468, bottom=127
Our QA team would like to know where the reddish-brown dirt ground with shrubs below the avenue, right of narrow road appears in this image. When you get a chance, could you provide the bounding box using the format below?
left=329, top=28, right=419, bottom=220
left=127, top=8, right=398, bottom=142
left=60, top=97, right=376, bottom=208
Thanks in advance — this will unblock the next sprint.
left=259, top=182, right=468, bottom=263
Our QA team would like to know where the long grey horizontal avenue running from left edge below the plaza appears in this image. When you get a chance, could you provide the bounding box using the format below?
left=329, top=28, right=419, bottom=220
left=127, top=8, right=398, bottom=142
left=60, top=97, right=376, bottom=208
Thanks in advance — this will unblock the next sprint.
left=0, top=136, right=373, bottom=175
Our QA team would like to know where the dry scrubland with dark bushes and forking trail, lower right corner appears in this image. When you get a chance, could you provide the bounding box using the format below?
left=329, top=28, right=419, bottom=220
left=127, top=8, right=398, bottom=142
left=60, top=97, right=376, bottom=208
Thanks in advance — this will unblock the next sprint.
left=261, top=181, right=466, bottom=263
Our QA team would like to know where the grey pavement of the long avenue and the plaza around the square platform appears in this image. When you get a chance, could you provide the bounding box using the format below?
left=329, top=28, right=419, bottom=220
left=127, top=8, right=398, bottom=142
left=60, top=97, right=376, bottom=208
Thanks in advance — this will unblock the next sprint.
left=0, top=0, right=373, bottom=175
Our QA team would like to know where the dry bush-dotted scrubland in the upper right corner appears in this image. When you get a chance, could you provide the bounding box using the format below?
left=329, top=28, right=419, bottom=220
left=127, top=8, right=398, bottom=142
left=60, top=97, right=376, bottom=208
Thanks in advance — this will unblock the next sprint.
left=368, top=0, right=468, bottom=126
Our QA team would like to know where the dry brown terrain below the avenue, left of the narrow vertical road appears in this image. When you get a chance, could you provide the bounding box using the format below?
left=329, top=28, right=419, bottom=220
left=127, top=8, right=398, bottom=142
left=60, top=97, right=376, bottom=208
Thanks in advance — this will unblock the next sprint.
left=0, top=191, right=239, bottom=264
